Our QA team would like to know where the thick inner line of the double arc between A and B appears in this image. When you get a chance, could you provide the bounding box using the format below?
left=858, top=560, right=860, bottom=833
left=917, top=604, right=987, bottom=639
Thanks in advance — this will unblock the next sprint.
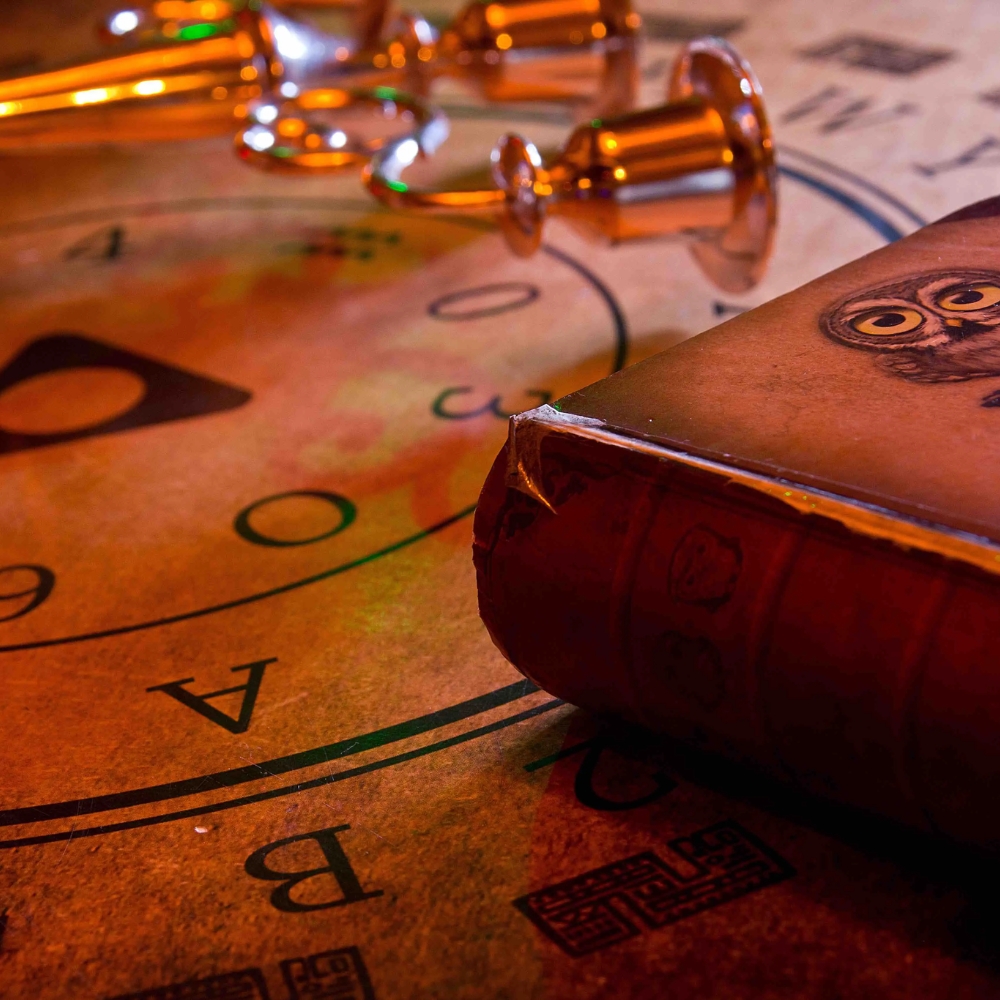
left=0, top=680, right=544, bottom=826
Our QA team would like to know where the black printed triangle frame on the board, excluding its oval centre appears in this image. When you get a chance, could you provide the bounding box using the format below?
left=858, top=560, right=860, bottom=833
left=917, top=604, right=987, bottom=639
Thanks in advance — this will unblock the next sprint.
left=0, top=332, right=252, bottom=455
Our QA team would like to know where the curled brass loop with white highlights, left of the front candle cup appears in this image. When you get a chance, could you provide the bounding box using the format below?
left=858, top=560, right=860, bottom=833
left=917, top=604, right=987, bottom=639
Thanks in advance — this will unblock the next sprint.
left=234, top=87, right=448, bottom=173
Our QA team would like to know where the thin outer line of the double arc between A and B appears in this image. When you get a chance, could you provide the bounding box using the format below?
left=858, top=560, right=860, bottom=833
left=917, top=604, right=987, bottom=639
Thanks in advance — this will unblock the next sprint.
left=0, top=698, right=566, bottom=851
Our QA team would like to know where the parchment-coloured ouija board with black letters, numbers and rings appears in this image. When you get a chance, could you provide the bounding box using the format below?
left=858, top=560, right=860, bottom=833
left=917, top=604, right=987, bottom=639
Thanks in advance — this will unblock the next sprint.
left=0, top=0, right=1000, bottom=1000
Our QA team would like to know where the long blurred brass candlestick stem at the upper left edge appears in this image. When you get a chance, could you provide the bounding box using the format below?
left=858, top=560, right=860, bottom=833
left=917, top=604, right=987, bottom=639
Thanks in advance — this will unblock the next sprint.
left=0, top=0, right=368, bottom=149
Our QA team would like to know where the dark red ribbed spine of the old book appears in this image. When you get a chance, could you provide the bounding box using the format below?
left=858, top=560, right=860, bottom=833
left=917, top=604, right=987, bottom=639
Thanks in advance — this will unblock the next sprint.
left=474, top=433, right=1000, bottom=849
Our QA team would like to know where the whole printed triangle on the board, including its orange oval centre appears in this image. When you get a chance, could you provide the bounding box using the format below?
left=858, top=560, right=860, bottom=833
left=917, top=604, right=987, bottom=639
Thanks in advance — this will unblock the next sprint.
left=0, top=333, right=251, bottom=455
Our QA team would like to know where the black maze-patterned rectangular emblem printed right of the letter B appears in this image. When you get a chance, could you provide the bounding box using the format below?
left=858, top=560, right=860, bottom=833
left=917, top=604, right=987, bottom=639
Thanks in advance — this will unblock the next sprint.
left=514, top=820, right=795, bottom=956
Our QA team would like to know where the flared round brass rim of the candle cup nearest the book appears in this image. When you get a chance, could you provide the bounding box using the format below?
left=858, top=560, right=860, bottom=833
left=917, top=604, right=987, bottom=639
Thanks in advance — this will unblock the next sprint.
left=667, top=37, right=778, bottom=292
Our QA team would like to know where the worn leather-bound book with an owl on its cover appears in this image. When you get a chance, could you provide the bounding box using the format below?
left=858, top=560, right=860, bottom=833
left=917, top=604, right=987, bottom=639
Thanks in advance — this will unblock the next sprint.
left=474, top=199, right=1000, bottom=850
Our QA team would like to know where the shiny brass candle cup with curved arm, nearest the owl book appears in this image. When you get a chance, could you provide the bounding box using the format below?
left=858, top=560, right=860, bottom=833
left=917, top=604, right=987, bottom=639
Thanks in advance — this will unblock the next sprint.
left=365, top=38, right=777, bottom=292
